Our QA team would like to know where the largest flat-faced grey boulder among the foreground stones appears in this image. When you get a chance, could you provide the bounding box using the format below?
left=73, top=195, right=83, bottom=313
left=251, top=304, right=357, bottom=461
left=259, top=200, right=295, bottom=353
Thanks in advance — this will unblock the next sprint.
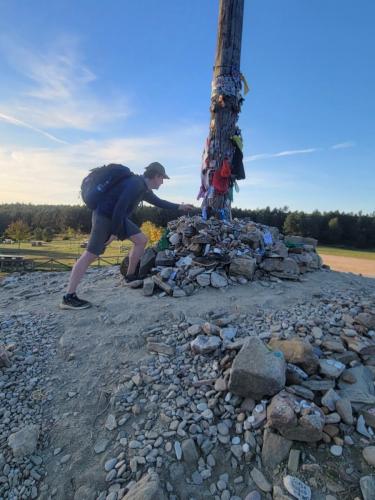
left=229, top=337, right=286, bottom=399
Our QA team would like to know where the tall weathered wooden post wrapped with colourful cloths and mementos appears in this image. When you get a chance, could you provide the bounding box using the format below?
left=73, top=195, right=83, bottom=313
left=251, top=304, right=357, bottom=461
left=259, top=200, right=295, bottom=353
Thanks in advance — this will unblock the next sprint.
left=200, top=0, right=244, bottom=219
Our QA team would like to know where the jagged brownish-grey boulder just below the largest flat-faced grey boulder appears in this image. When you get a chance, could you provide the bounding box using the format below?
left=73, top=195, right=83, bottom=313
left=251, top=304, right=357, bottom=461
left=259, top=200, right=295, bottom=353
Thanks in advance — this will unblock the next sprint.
left=267, top=391, right=325, bottom=443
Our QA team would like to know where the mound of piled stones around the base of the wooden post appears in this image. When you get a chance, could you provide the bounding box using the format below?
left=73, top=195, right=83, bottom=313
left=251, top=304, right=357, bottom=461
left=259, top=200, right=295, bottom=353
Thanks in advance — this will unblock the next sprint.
left=123, top=216, right=322, bottom=297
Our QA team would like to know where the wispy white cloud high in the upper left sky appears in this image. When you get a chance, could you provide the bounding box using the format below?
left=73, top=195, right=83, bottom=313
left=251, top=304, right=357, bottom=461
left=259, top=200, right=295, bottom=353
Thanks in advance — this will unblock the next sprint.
left=0, top=38, right=130, bottom=130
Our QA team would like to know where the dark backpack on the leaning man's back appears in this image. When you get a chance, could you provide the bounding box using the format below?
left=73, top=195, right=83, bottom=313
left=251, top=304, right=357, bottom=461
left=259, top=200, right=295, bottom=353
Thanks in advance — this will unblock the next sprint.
left=81, top=163, right=134, bottom=210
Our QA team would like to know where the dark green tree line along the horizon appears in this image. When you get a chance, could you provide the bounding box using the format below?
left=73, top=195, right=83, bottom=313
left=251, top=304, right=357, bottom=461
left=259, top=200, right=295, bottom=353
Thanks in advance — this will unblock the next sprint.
left=0, top=203, right=375, bottom=249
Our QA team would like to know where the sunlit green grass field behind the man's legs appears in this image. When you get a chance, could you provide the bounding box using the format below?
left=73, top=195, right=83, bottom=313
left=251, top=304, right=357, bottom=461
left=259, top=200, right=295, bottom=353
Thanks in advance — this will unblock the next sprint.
left=0, top=236, right=131, bottom=271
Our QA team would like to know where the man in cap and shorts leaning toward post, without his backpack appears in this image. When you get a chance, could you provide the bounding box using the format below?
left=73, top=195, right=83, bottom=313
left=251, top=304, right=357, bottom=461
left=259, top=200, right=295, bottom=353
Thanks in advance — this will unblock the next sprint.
left=60, top=162, right=194, bottom=309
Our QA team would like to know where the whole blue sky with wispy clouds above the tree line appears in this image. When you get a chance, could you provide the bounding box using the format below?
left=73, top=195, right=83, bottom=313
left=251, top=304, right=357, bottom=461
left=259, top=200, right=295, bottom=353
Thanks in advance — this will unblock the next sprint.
left=0, top=0, right=375, bottom=213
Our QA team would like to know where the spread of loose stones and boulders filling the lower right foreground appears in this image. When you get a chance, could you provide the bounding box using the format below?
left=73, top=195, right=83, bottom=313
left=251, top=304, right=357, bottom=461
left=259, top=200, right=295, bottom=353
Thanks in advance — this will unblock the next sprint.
left=94, top=295, right=375, bottom=500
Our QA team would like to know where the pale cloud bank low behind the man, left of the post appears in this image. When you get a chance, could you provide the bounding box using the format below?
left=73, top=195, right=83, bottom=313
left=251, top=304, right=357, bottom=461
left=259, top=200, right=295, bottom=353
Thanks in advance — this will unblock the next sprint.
left=0, top=127, right=206, bottom=204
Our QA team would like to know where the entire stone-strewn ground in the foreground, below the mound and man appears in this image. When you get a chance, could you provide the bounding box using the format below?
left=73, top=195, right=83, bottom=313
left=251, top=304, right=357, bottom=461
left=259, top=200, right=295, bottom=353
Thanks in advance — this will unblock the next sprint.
left=0, top=267, right=375, bottom=500
